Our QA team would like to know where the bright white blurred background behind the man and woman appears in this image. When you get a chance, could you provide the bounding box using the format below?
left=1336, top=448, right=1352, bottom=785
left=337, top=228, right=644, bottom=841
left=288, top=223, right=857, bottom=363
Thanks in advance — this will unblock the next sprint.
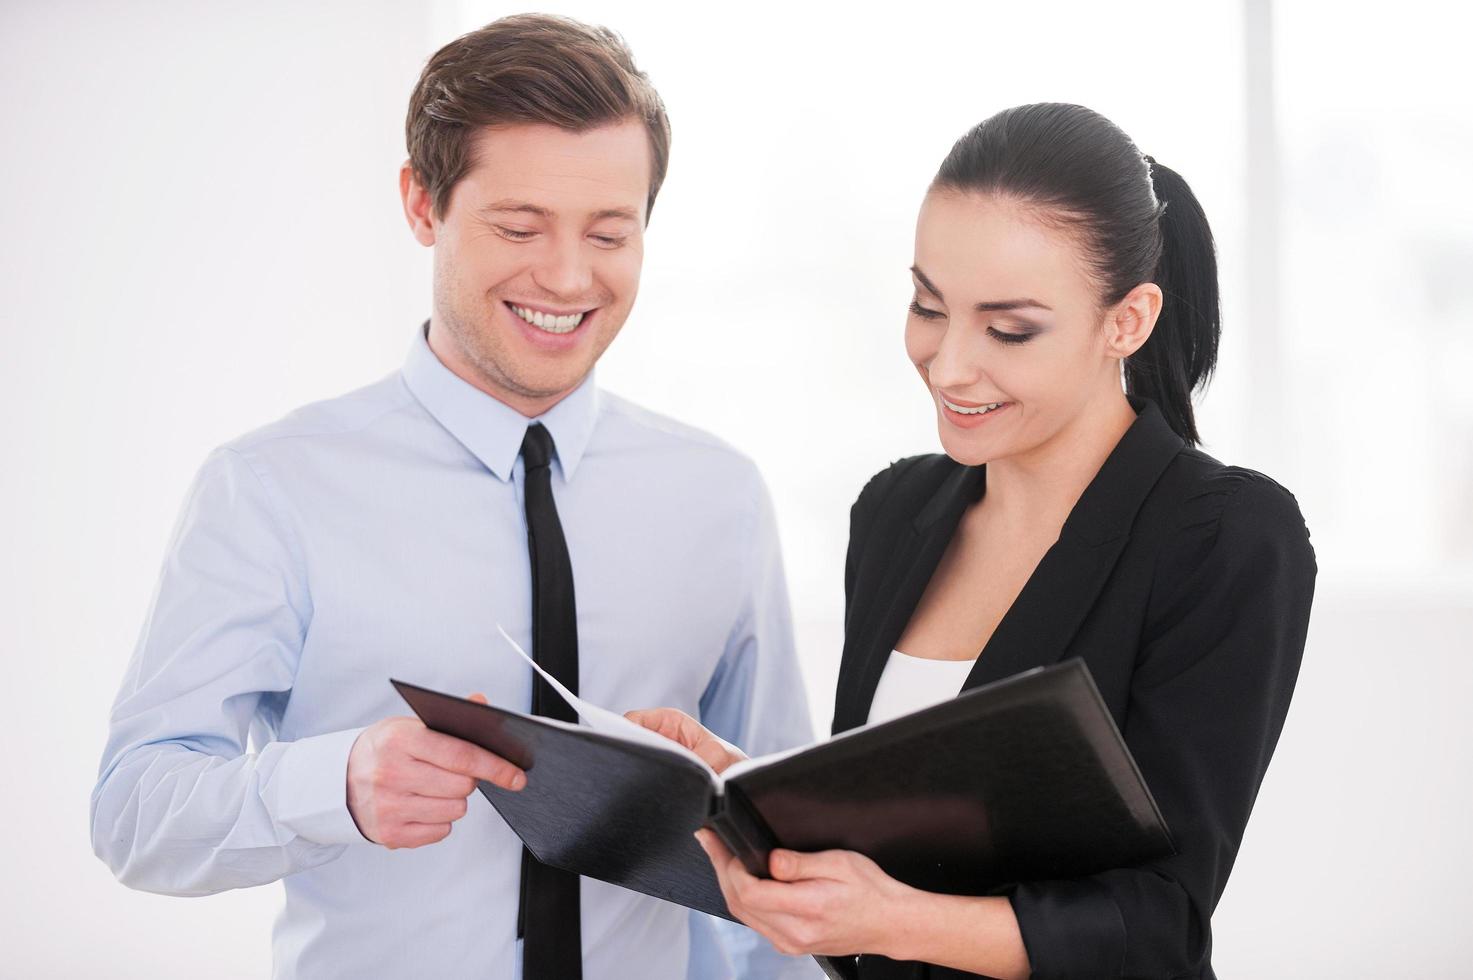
left=0, top=0, right=1473, bottom=977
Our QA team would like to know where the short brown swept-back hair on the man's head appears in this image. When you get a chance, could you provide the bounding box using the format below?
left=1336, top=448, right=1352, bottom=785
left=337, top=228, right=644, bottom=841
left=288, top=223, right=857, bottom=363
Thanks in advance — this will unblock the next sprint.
left=404, top=13, right=670, bottom=221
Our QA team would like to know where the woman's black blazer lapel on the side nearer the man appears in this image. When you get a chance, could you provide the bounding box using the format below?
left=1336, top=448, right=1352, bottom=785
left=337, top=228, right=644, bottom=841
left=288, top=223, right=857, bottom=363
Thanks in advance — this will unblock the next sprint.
left=834, top=466, right=987, bottom=734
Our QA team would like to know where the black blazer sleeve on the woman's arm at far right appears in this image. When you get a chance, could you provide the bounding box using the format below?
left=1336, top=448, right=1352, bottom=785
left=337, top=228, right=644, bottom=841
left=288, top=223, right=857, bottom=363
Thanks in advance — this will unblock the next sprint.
left=1010, top=467, right=1317, bottom=980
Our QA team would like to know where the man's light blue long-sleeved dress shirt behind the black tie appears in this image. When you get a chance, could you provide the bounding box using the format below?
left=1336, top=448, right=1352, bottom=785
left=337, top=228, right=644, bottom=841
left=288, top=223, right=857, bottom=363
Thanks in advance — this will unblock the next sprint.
left=91, top=330, right=816, bottom=980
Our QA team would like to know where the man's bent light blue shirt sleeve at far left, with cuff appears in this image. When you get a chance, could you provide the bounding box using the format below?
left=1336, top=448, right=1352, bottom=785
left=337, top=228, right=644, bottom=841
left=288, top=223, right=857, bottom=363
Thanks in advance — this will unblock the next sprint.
left=91, top=448, right=364, bottom=895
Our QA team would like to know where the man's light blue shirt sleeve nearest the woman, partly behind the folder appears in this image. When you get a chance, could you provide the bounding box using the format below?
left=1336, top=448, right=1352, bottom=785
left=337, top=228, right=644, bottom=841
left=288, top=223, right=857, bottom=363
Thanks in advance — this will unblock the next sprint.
left=689, top=462, right=823, bottom=980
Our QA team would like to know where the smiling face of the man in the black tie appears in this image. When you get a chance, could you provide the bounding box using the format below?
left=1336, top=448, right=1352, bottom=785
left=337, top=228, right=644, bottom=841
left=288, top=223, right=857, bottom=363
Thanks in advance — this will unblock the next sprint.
left=401, top=119, right=651, bottom=416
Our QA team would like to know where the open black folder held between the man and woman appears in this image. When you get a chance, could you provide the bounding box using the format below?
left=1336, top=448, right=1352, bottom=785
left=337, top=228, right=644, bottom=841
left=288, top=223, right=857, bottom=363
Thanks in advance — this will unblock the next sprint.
left=393, top=659, right=1173, bottom=972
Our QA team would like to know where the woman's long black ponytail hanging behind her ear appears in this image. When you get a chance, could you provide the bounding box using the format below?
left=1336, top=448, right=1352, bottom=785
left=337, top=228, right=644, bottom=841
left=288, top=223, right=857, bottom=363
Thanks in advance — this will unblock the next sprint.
left=1125, top=156, right=1223, bottom=445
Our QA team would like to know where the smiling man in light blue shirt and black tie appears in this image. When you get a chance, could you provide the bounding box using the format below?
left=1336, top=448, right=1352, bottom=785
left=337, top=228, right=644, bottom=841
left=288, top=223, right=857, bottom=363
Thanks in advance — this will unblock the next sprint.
left=91, top=15, right=815, bottom=980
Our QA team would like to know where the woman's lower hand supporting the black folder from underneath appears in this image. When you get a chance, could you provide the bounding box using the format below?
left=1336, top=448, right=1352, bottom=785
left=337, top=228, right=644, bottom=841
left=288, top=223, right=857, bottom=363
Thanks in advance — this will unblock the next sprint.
left=695, top=830, right=921, bottom=956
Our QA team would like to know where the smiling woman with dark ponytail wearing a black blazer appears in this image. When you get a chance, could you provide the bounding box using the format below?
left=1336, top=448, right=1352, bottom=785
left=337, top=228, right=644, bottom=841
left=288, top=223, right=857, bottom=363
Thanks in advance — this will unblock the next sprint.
left=632, top=103, right=1315, bottom=980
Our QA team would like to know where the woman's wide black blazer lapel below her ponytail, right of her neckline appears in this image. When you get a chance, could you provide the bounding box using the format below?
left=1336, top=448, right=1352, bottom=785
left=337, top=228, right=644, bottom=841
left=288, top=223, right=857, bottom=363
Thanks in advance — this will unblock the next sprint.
left=962, top=398, right=1186, bottom=690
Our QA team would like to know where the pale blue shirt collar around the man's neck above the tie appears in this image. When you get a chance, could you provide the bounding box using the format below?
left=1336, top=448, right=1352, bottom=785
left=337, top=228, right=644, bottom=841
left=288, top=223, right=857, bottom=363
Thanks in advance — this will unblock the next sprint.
left=404, top=321, right=598, bottom=480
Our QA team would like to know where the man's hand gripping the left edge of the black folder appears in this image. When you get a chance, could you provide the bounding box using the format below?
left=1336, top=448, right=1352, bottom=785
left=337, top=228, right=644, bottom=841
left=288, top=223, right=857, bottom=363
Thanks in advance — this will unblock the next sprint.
left=348, top=694, right=527, bottom=847
